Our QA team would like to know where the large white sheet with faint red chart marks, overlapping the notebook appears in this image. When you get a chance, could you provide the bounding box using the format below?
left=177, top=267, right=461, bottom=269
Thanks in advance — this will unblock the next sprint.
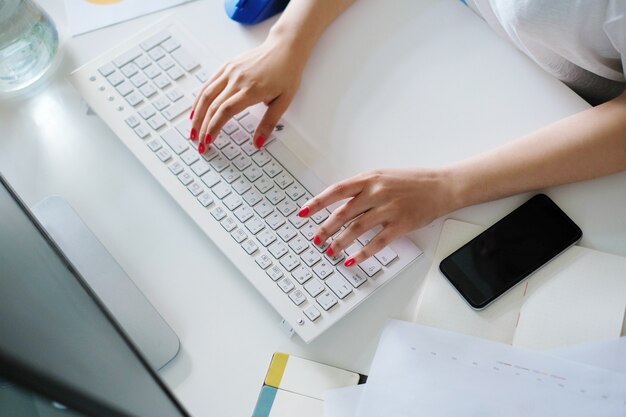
left=357, top=321, right=626, bottom=417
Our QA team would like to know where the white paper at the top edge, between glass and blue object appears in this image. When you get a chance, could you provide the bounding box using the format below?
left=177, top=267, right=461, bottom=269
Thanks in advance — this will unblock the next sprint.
left=65, top=0, right=190, bottom=36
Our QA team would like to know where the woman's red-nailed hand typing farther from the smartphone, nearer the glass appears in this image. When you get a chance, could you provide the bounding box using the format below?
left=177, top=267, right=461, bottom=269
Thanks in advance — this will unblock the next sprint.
left=189, top=36, right=307, bottom=153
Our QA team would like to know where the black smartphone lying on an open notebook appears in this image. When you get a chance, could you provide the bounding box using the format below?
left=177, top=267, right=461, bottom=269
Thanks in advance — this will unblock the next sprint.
left=439, top=194, right=583, bottom=310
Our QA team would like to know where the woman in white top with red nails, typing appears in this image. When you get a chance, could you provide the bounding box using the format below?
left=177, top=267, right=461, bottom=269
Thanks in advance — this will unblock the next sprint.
left=190, top=0, right=626, bottom=266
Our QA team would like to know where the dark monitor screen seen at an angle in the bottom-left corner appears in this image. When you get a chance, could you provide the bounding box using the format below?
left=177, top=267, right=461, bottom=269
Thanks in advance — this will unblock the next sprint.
left=0, top=176, right=187, bottom=417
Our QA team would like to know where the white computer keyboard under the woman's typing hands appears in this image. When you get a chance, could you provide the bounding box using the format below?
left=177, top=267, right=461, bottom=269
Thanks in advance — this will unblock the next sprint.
left=71, top=19, right=422, bottom=343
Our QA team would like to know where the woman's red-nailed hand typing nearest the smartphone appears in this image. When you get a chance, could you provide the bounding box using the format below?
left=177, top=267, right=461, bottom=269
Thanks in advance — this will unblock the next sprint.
left=298, top=169, right=455, bottom=266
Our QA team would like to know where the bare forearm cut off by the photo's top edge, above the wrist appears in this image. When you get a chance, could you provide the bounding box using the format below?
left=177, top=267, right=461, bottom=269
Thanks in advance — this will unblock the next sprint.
left=268, top=0, right=354, bottom=61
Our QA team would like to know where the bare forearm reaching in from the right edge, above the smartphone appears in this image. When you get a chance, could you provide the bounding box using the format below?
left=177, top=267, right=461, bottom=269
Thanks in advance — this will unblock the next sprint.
left=445, top=93, right=626, bottom=210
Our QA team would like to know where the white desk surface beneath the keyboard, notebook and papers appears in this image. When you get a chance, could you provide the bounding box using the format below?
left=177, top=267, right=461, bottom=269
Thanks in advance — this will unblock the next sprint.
left=0, top=0, right=626, bottom=416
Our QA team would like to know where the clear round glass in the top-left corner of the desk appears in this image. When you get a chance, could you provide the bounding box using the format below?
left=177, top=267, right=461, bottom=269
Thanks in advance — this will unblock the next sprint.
left=0, top=0, right=59, bottom=95
